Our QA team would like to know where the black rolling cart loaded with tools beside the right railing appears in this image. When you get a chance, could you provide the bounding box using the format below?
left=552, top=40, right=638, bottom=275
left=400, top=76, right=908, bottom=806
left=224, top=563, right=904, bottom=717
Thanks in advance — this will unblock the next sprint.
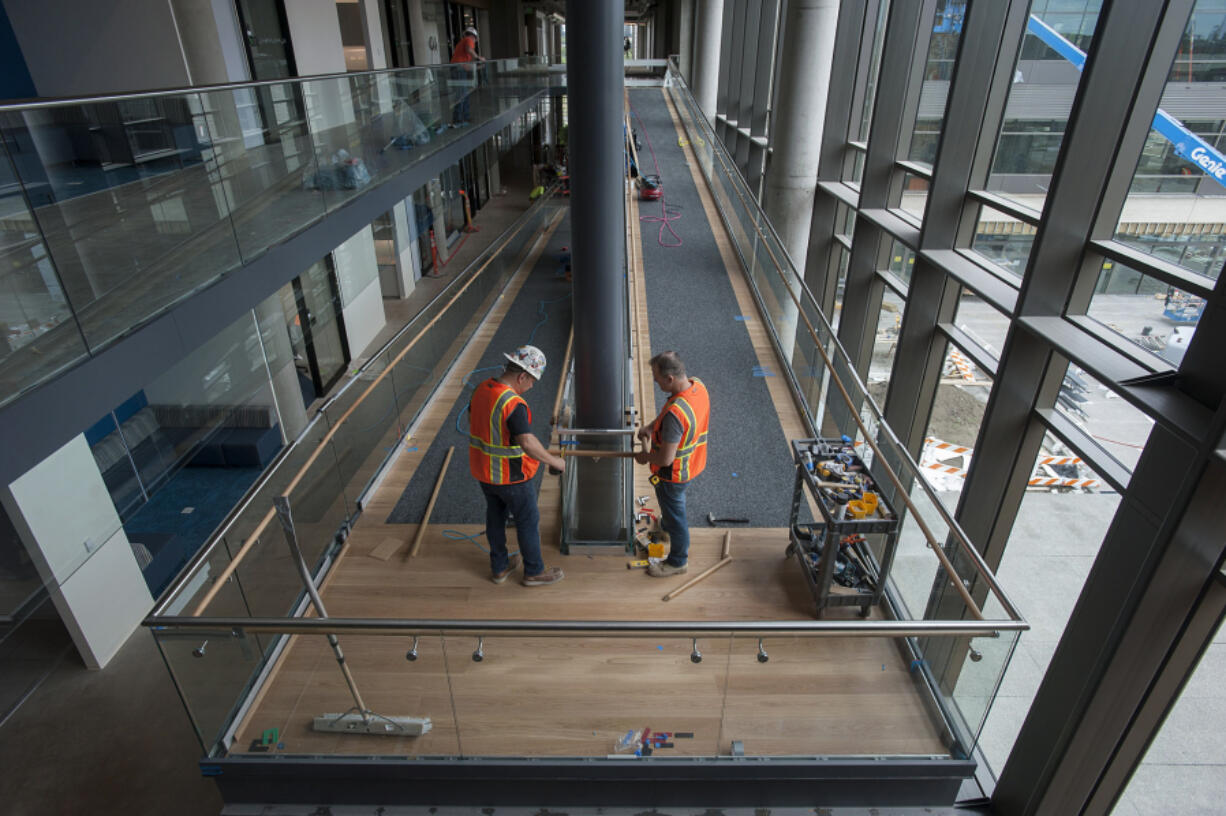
left=787, top=439, right=899, bottom=618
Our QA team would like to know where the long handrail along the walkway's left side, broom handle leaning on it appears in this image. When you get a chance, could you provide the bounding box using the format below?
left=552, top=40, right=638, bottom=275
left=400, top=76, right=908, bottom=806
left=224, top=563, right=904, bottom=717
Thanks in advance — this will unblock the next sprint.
left=151, top=185, right=557, bottom=616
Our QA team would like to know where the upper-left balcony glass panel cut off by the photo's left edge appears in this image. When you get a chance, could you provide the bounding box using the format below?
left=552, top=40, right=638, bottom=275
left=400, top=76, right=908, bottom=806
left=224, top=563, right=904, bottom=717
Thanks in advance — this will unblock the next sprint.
left=0, top=139, right=87, bottom=403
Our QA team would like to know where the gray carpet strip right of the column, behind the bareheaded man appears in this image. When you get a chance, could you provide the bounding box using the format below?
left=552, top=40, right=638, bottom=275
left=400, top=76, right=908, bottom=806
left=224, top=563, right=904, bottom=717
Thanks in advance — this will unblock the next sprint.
left=630, top=88, right=808, bottom=527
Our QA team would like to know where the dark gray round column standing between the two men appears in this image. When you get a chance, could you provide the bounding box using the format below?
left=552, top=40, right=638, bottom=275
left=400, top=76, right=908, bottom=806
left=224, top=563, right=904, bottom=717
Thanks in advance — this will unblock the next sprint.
left=566, top=0, right=628, bottom=540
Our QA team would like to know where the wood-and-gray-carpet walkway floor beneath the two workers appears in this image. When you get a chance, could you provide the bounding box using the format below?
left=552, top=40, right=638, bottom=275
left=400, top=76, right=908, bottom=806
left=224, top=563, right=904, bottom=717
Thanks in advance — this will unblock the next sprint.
left=230, top=88, right=949, bottom=757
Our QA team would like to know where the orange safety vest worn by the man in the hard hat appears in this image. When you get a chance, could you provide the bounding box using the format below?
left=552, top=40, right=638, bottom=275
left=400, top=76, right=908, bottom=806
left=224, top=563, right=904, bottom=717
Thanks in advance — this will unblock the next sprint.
left=468, top=380, right=541, bottom=484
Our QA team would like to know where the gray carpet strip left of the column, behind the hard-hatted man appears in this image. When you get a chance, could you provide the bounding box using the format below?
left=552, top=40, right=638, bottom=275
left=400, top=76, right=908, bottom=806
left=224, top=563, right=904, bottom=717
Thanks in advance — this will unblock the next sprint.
left=387, top=211, right=570, bottom=524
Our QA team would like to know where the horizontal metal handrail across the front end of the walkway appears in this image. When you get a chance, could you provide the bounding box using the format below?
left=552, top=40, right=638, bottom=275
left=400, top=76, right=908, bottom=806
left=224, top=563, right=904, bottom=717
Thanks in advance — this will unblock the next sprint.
left=143, top=616, right=1030, bottom=637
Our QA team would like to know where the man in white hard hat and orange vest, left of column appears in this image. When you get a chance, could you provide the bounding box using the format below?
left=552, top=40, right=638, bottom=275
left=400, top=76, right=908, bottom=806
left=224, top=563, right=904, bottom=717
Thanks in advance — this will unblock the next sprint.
left=468, top=346, right=566, bottom=587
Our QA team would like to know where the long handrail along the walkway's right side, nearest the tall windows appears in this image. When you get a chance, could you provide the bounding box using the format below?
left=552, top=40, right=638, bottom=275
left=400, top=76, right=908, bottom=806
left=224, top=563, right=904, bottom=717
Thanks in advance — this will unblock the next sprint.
left=669, top=65, right=1021, bottom=619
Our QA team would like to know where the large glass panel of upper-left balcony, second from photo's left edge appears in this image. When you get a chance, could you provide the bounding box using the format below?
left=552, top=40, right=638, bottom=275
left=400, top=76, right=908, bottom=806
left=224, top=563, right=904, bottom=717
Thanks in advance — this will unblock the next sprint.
left=0, top=93, right=239, bottom=349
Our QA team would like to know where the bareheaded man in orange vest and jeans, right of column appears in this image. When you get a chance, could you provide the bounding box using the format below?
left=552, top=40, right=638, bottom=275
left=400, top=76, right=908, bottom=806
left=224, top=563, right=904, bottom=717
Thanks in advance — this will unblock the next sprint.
left=634, top=352, right=711, bottom=578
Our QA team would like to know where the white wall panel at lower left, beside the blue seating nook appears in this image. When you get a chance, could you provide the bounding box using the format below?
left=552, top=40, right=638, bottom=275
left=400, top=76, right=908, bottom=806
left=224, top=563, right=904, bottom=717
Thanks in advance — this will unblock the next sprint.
left=0, top=435, right=153, bottom=669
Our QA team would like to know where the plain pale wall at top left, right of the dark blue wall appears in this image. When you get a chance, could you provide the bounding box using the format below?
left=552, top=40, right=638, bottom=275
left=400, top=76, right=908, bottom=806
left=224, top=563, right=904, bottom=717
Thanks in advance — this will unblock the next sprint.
left=4, top=0, right=188, bottom=97
